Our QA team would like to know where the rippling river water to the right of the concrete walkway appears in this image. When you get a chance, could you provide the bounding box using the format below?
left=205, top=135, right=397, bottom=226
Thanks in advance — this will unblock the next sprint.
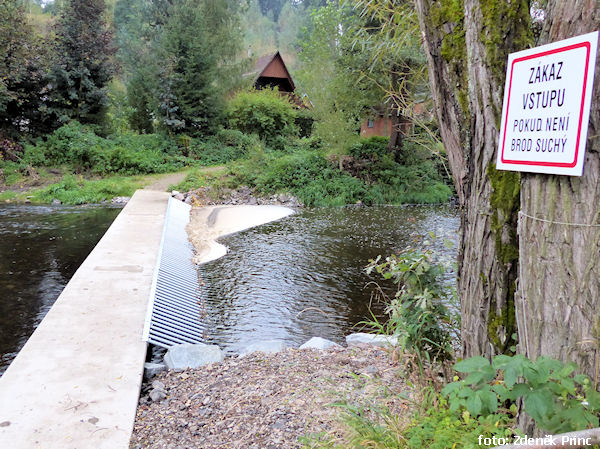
left=200, top=206, right=458, bottom=351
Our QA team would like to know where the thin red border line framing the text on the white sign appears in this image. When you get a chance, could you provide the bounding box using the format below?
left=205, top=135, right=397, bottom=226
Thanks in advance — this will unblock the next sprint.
left=500, top=41, right=591, bottom=168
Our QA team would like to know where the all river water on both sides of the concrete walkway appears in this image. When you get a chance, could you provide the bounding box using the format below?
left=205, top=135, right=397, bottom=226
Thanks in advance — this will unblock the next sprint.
left=0, top=205, right=458, bottom=374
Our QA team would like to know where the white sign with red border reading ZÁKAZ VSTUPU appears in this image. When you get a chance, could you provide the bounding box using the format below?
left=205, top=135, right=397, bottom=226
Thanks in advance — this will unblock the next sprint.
left=496, top=31, right=598, bottom=176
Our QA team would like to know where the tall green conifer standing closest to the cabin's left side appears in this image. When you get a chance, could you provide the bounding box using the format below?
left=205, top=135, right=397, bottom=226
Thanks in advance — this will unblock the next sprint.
left=157, top=0, right=241, bottom=134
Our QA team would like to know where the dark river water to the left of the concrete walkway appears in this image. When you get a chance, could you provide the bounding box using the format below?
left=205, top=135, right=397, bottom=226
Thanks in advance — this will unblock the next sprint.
left=0, top=205, right=121, bottom=374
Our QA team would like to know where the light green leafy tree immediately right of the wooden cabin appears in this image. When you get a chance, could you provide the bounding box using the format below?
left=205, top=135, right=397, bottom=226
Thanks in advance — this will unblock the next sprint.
left=297, top=2, right=383, bottom=154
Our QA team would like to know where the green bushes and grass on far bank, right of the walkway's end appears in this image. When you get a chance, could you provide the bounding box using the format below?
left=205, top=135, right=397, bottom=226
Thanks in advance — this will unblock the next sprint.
left=175, top=146, right=452, bottom=206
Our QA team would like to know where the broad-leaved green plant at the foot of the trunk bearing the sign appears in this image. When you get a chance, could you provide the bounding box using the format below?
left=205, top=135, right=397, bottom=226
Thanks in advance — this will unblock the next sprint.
left=442, top=355, right=600, bottom=433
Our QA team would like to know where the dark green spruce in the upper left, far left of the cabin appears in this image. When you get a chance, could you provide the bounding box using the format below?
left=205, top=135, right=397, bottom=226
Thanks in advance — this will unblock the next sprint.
left=50, top=0, right=114, bottom=126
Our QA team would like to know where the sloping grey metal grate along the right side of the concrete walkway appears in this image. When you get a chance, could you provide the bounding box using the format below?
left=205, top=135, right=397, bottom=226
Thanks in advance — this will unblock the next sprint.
left=144, top=198, right=204, bottom=348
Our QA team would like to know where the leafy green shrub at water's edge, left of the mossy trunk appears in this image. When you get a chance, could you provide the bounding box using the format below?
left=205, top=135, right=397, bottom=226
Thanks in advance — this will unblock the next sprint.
left=366, top=249, right=456, bottom=362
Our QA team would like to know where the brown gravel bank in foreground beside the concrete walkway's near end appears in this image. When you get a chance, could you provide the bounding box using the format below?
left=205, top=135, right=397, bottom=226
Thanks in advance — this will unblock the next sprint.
left=130, top=346, right=410, bottom=449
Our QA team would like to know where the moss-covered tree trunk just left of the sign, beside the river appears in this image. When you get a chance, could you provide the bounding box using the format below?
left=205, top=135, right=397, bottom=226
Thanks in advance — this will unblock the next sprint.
left=416, top=0, right=530, bottom=357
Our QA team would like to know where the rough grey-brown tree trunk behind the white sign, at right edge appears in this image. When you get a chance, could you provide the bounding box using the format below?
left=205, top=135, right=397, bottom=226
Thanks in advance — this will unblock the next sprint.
left=516, top=0, right=600, bottom=387
